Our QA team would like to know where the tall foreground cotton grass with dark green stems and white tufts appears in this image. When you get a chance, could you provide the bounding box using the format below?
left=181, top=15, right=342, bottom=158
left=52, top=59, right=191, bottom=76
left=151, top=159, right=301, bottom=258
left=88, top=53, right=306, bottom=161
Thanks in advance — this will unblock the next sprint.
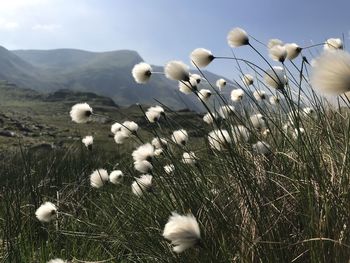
left=0, top=28, right=350, bottom=262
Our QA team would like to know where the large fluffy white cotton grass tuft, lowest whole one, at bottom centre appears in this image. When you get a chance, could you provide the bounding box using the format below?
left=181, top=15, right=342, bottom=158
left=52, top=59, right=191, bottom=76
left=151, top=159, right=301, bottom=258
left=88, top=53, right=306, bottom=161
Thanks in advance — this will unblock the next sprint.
left=163, top=212, right=201, bottom=253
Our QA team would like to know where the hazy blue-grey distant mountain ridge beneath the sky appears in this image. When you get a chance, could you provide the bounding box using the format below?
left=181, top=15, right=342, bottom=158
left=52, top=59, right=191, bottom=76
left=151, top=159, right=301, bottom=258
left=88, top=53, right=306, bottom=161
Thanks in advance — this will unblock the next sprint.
left=0, top=47, right=227, bottom=111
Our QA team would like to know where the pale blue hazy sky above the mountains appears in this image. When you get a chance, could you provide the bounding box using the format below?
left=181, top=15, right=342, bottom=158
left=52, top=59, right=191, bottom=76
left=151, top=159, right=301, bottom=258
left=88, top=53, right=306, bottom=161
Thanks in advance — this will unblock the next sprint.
left=0, top=0, right=350, bottom=77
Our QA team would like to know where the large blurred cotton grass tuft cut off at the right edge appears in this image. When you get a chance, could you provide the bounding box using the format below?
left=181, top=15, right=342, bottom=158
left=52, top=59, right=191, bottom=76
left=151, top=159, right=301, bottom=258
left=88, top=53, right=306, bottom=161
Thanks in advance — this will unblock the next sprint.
left=311, top=50, right=350, bottom=95
